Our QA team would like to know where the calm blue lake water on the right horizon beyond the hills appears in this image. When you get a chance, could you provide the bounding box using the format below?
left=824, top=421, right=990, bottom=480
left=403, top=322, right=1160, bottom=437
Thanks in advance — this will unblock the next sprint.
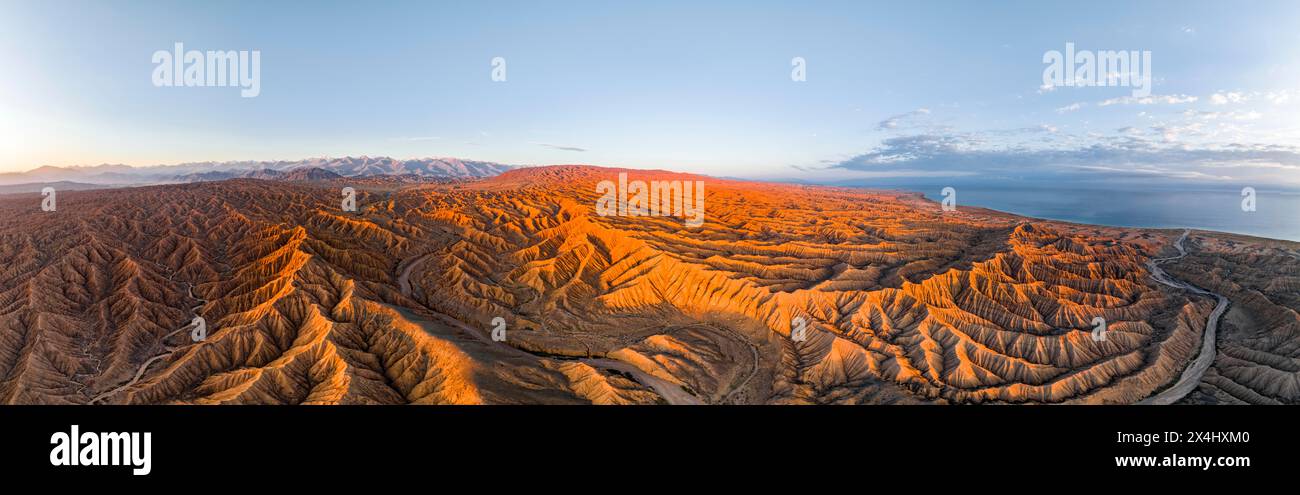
left=915, top=186, right=1300, bottom=240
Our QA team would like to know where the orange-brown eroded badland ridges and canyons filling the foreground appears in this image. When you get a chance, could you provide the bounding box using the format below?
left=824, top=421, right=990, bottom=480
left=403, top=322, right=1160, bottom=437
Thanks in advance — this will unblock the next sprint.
left=0, top=166, right=1300, bottom=404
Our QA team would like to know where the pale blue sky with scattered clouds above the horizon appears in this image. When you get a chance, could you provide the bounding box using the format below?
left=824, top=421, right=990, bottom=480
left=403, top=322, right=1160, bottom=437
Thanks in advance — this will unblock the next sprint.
left=0, top=0, right=1300, bottom=187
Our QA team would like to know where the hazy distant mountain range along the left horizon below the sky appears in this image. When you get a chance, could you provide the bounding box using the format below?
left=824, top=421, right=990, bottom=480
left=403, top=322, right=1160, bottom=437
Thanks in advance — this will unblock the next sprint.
left=0, top=156, right=512, bottom=186
